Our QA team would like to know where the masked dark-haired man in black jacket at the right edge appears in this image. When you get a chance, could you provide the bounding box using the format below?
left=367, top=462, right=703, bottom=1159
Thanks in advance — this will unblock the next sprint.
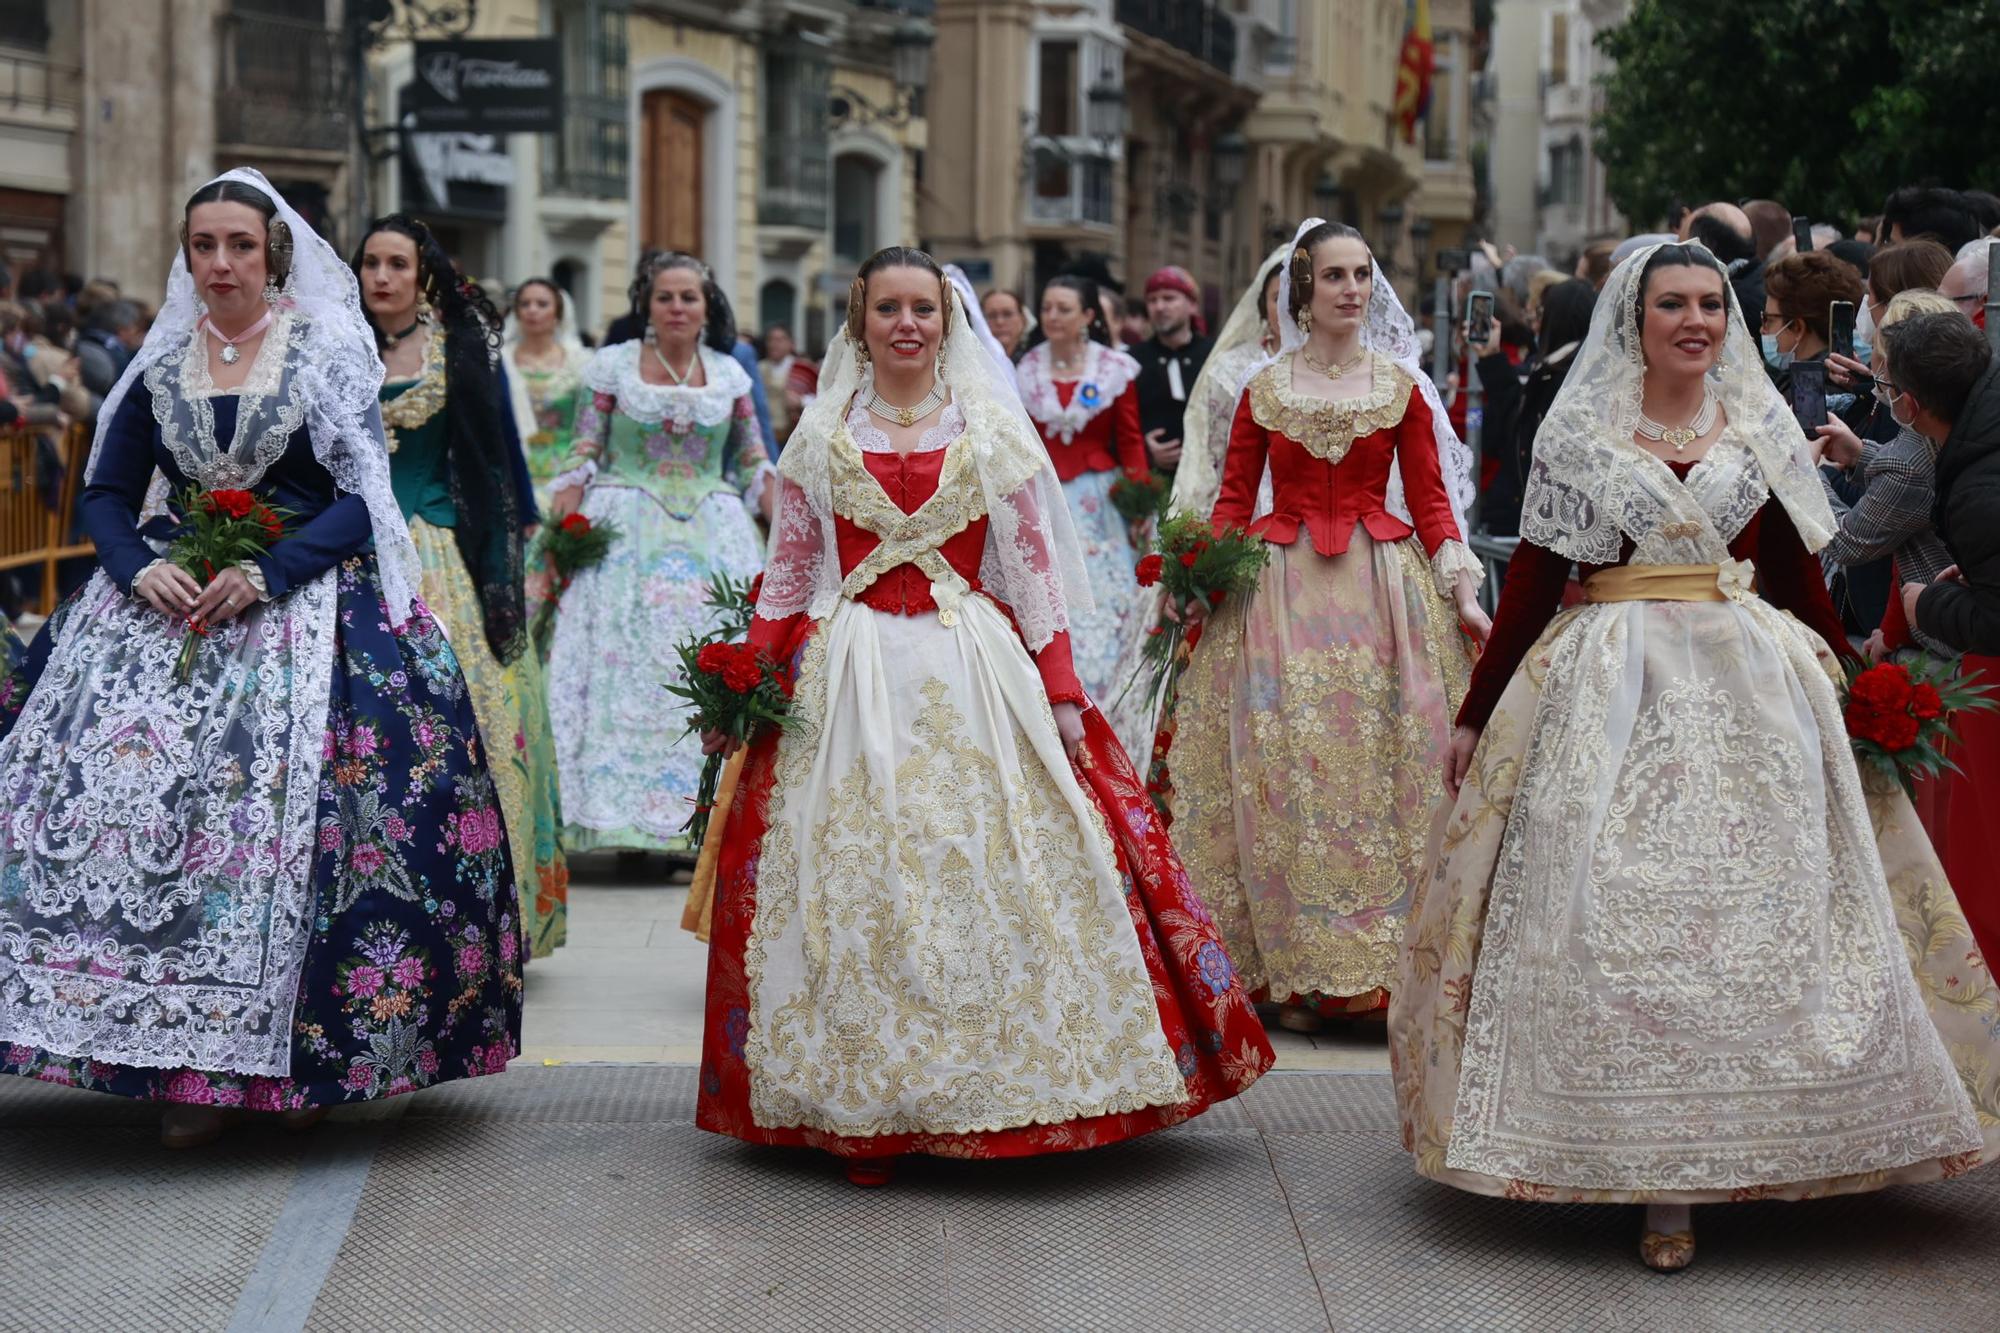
left=1876, top=314, right=2000, bottom=654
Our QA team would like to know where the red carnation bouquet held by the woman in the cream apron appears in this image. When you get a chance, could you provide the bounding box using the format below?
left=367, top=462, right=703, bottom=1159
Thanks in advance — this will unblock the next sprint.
left=666, top=574, right=792, bottom=849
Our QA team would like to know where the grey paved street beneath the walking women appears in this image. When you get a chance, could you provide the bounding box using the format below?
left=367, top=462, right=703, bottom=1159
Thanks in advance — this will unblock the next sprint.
left=0, top=863, right=2000, bottom=1331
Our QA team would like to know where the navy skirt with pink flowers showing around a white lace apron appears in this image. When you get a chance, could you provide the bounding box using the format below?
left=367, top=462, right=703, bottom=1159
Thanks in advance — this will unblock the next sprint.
left=0, top=556, right=522, bottom=1111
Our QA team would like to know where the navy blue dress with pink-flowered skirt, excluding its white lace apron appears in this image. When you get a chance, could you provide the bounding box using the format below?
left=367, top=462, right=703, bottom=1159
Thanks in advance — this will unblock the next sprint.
left=0, top=386, right=522, bottom=1111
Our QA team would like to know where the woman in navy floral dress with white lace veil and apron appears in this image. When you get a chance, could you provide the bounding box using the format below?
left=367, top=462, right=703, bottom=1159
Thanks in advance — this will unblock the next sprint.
left=0, top=170, right=520, bottom=1147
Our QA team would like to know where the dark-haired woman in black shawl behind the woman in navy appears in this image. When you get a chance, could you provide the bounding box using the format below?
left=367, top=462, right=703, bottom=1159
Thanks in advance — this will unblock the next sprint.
left=354, top=214, right=570, bottom=957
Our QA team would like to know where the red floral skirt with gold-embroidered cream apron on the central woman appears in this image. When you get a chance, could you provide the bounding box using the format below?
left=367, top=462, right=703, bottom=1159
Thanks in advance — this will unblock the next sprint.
left=696, top=598, right=1272, bottom=1157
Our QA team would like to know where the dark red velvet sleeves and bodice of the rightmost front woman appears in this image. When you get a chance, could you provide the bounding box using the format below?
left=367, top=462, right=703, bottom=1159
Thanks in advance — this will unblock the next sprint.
left=1458, top=462, right=1854, bottom=729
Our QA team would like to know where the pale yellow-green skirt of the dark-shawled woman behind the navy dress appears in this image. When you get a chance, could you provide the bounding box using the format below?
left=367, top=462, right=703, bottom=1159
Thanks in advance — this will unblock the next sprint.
left=410, top=518, right=570, bottom=959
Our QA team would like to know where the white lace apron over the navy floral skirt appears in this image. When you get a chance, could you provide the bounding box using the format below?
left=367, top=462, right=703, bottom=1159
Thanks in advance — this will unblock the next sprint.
left=0, top=570, right=336, bottom=1075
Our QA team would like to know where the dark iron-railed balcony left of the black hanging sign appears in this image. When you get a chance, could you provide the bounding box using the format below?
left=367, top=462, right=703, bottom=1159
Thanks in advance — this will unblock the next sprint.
left=216, top=12, right=354, bottom=154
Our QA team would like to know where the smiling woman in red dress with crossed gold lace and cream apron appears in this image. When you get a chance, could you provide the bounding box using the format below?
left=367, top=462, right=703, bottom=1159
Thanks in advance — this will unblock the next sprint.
left=696, top=248, right=1272, bottom=1185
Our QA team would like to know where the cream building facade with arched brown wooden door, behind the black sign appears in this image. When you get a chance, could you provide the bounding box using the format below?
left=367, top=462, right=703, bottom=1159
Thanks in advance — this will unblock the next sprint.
left=370, top=0, right=928, bottom=348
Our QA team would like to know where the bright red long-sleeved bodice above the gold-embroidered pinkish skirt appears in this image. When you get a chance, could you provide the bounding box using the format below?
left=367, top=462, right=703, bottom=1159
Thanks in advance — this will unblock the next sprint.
left=1214, top=386, right=1464, bottom=556
